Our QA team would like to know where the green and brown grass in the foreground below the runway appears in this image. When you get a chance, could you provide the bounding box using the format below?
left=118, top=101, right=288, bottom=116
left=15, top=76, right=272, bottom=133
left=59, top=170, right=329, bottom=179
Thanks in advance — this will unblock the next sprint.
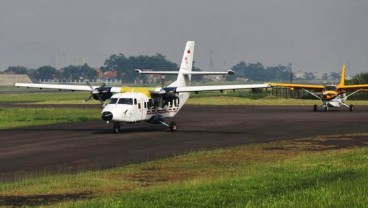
left=0, top=134, right=368, bottom=207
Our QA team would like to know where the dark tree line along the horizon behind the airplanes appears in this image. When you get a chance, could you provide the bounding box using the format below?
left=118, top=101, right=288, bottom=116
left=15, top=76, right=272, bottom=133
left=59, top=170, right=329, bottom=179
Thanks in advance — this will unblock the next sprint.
left=4, top=53, right=368, bottom=83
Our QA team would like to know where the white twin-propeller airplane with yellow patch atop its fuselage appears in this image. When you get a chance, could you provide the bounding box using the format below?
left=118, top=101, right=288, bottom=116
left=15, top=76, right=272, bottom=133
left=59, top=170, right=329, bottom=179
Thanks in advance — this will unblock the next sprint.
left=15, top=41, right=268, bottom=133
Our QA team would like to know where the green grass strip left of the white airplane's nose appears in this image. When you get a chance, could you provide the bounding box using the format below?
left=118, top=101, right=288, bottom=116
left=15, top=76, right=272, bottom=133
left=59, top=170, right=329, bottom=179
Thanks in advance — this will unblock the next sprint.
left=0, top=107, right=101, bottom=129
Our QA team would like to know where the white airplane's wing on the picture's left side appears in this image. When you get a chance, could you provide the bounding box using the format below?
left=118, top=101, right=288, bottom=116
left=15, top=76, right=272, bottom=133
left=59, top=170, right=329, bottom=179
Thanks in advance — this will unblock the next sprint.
left=15, top=83, right=121, bottom=93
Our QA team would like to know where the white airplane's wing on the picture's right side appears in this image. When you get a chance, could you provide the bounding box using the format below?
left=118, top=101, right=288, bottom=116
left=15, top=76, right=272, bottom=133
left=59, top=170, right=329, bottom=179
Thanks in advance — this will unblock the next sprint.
left=176, top=84, right=269, bottom=92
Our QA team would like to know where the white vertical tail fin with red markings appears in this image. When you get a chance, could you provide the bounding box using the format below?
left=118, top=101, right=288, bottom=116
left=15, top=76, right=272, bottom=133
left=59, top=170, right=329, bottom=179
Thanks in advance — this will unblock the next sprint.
left=169, top=41, right=195, bottom=87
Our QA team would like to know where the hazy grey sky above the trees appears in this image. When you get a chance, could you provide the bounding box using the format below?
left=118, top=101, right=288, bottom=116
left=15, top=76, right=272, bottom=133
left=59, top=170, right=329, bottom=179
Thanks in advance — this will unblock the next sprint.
left=0, top=0, right=368, bottom=75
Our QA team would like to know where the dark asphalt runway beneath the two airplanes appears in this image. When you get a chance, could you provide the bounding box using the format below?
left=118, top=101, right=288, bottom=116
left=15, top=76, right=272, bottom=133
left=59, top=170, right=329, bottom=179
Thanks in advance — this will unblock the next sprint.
left=0, top=106, right=368, bottom=180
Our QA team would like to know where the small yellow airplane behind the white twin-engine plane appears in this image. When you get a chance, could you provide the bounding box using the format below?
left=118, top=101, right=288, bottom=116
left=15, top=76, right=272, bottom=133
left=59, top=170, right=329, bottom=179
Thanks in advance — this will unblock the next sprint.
left=268, top=64, right=368, bottom=112
